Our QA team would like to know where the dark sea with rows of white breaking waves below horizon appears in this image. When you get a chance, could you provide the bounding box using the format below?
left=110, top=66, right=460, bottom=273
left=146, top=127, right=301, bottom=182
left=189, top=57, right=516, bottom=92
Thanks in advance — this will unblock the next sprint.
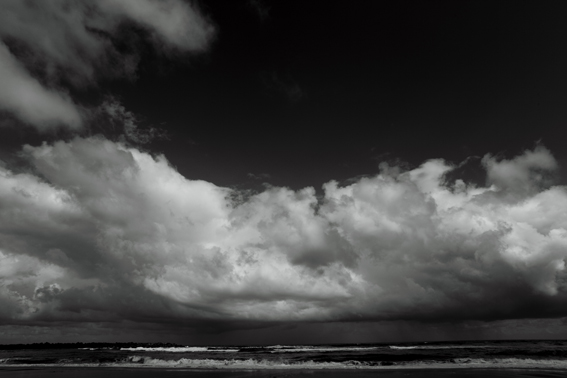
left=0, top=340, right=567, bottom=378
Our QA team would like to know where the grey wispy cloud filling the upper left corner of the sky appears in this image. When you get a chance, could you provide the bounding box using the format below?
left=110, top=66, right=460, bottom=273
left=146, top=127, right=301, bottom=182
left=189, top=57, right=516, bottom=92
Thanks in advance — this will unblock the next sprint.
left=0, top=0, right=214, bottom=130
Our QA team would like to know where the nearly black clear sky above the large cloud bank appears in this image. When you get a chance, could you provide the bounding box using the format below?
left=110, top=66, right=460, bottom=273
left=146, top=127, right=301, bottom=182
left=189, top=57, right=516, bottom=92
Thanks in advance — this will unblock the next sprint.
left=122, top=1, right=567, bottom=189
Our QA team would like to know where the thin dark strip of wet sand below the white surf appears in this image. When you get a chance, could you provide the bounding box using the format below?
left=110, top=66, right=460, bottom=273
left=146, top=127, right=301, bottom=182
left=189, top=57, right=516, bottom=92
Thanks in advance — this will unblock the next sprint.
left=0, top=367, right=567, bottom=378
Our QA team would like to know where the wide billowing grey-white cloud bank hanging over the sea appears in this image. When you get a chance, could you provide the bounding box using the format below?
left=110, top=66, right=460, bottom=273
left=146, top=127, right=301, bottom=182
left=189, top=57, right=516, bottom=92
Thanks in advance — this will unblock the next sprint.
left=0, top=137, right=567, bottom=325
